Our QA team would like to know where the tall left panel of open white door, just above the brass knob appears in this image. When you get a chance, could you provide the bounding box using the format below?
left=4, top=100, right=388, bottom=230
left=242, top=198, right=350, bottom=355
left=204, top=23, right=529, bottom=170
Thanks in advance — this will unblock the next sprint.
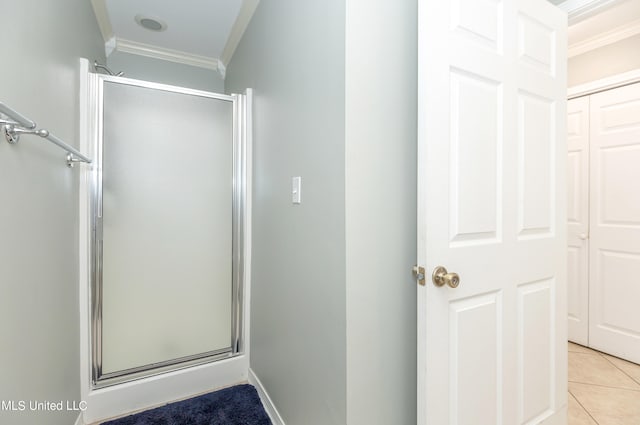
left=449, top=70, right=502, bottom=246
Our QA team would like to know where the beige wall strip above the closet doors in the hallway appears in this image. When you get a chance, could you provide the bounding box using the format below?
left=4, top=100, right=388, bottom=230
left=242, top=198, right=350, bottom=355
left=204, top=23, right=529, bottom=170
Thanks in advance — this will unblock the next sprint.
left=568, top=35, right=640, bottom=87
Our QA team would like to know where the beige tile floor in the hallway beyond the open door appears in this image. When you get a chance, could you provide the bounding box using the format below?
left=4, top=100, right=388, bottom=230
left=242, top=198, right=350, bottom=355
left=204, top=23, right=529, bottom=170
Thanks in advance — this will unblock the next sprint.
left=569, top=342, right=640, bottom=425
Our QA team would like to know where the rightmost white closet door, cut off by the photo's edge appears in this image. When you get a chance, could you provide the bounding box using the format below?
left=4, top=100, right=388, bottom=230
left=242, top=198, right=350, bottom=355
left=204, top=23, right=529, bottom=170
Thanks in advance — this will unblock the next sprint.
left=589, top=84, right=640, bottom=363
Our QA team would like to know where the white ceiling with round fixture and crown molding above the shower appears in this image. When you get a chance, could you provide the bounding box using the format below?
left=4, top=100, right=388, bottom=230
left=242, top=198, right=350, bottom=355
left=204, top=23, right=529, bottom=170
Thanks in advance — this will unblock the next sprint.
left=91, top=0, right=259, bottom=69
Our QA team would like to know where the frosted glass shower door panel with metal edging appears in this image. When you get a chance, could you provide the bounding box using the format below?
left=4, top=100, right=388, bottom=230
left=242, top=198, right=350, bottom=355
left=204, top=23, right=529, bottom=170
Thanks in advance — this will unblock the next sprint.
left=93, top=77, right=242, bottom=384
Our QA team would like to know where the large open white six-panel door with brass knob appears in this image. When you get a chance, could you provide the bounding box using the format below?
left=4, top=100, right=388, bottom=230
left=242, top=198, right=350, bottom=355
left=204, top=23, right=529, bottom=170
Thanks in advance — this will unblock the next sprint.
left=418, top=0, right=567, bottom=425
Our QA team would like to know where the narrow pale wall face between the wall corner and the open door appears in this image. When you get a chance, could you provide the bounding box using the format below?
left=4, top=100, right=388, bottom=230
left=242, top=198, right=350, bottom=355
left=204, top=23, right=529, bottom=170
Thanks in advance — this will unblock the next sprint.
left=346, top=0, right=418, bottom=425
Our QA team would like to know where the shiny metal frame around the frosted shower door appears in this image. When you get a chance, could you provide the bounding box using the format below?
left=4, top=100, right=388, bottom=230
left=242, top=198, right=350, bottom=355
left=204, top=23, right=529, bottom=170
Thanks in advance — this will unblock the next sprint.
left=89, top=74, right=247, bottom=389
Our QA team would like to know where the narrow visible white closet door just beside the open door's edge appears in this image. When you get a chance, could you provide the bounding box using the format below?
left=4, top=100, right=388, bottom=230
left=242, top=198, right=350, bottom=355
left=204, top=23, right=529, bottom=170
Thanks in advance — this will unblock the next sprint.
left=567, top=96, right=589, bottom=345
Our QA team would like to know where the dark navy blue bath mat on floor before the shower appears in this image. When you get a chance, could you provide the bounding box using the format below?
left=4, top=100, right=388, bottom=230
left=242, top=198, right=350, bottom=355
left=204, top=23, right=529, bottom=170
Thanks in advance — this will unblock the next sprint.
left=103, top=384, right=271, bottom=425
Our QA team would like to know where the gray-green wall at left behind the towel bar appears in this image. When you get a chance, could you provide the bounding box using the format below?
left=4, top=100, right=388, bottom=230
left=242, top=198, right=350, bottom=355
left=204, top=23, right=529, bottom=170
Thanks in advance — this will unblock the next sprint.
left=0, top=0, right=104, bottom=425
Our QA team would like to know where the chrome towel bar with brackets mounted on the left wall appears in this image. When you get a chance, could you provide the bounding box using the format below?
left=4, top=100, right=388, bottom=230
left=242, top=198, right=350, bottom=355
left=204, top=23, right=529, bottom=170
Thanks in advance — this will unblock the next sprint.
left=0, top=102, right=91, bottom=167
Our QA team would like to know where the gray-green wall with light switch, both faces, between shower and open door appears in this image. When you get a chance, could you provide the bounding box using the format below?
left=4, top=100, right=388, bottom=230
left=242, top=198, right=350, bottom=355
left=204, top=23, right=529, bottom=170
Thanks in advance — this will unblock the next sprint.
left=226, top=0, right=417, bottom=425
